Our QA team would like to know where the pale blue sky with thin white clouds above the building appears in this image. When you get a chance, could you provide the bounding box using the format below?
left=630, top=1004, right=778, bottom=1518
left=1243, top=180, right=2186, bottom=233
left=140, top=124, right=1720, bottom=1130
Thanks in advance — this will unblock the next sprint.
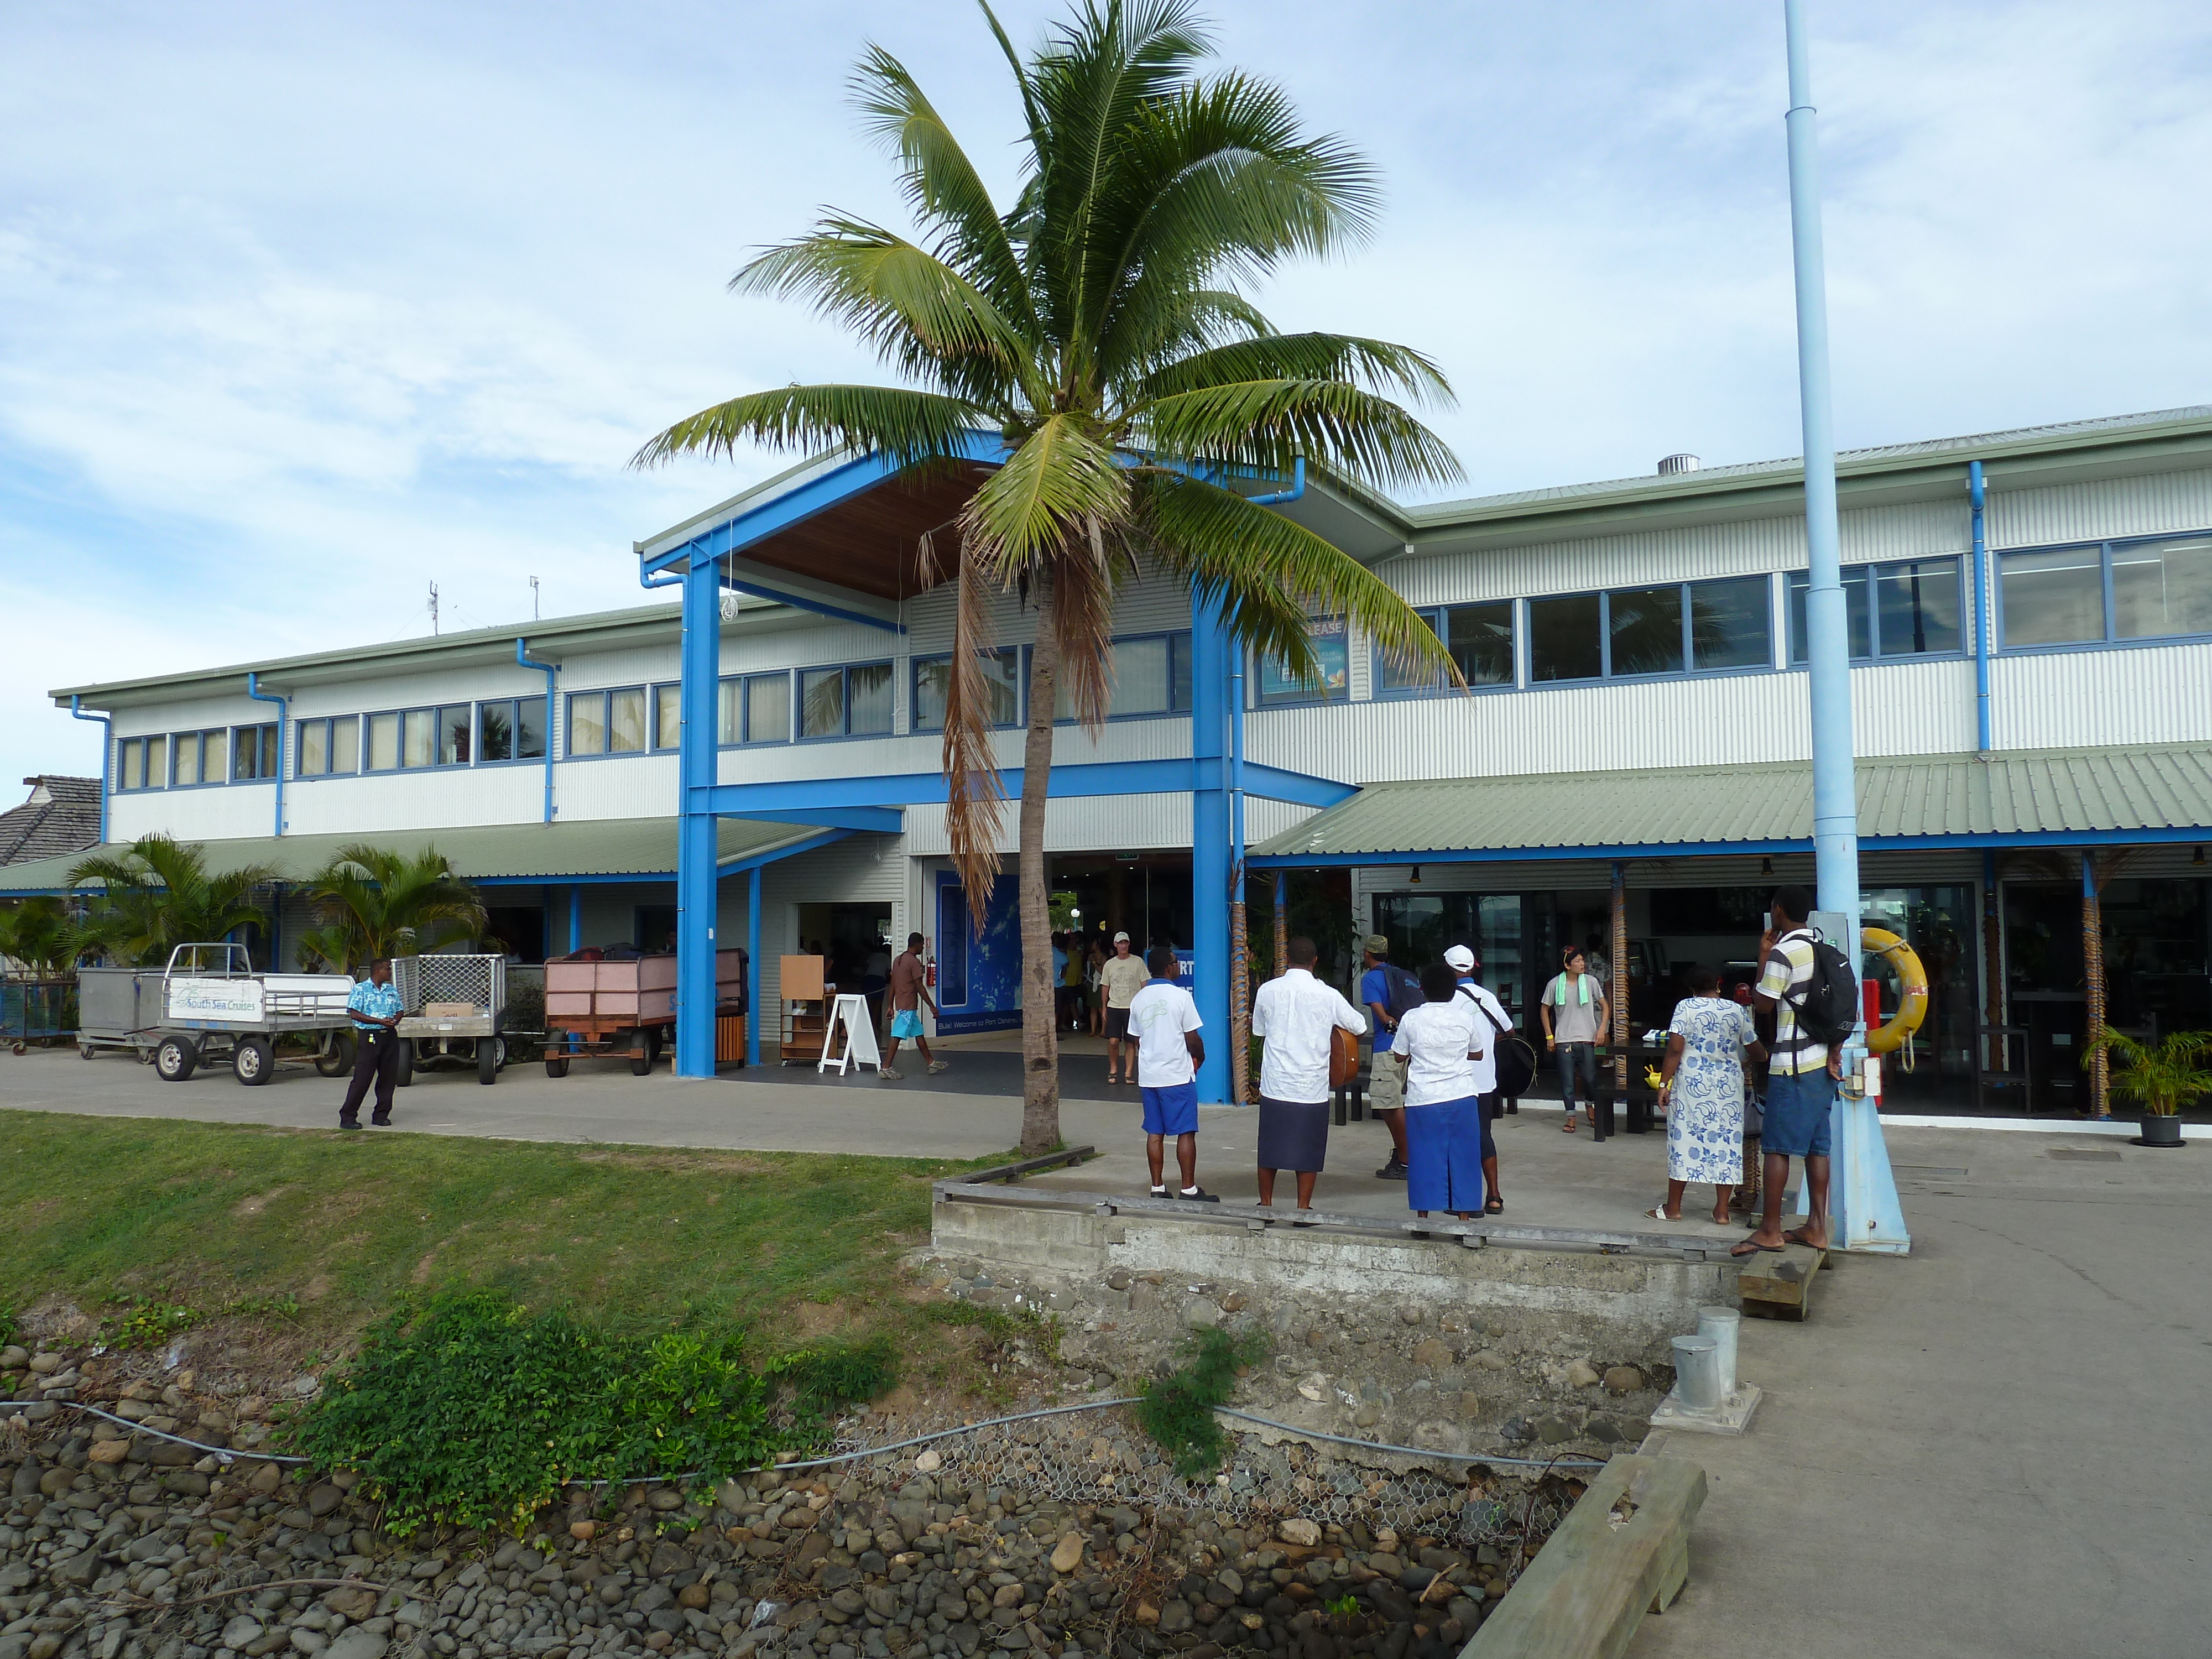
left=0, top=0, right=2212, bottom=801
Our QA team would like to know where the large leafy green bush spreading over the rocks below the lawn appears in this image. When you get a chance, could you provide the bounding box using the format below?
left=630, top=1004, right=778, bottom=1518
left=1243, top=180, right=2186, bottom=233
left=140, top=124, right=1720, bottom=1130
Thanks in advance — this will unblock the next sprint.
left=290, top=1292, right=896, bottom=1533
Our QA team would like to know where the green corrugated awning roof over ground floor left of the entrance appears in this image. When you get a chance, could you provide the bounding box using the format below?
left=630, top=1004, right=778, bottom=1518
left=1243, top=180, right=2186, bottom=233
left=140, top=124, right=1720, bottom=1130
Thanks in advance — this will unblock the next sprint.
left=0, top=818, right=823, bottom=894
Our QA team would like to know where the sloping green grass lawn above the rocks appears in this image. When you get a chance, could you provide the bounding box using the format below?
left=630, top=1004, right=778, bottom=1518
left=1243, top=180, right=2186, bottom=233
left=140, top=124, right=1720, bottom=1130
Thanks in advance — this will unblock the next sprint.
left=0, top=1113, right=973, bottom=1349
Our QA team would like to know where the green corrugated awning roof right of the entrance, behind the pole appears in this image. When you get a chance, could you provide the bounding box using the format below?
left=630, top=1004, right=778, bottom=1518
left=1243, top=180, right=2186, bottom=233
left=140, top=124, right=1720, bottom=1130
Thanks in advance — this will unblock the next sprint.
left=1252, top=745, right=2212, bottom=858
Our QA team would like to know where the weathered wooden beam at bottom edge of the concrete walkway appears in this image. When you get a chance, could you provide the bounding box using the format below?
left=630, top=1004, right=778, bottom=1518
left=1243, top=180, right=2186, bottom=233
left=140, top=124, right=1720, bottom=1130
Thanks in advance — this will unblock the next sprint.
left=1462, top=1453, right=1705, bottom=1659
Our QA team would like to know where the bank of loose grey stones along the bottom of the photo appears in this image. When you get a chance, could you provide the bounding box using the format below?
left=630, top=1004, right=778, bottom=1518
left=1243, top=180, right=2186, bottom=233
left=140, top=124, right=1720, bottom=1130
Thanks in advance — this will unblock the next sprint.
left=0, top=1349, right=1540, bottom=1659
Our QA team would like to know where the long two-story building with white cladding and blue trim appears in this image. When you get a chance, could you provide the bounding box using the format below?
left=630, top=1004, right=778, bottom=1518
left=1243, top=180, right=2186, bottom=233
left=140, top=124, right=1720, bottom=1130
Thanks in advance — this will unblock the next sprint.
left=17, top=407, right=2212, bottom=1106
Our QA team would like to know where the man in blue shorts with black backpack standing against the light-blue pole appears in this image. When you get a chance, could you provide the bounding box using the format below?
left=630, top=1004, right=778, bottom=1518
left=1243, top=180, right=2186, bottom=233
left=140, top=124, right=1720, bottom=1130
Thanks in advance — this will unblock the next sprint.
left=1728, top=885, right=1856, bottom=1256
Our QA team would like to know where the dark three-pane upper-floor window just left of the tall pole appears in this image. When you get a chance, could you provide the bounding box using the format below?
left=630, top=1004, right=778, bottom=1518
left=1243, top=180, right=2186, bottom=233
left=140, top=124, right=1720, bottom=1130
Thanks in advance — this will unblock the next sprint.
left=1528, top=575, right=1774, bottom=684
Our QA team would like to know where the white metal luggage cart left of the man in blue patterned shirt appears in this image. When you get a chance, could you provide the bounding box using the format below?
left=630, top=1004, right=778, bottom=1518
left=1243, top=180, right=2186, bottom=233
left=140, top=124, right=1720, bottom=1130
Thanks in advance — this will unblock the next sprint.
left=142, top=945, right=354, bottom=1088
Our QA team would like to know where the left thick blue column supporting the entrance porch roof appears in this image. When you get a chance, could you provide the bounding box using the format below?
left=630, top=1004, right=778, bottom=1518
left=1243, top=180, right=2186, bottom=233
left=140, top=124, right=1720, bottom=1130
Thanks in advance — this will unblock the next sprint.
left=675, top=557, right=721, bottom=1077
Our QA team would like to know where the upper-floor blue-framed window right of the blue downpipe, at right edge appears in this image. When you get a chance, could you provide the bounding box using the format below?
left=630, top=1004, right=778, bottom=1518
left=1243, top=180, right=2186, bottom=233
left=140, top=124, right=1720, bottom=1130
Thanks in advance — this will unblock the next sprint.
left=1997, top=531, right=2212, bottom=650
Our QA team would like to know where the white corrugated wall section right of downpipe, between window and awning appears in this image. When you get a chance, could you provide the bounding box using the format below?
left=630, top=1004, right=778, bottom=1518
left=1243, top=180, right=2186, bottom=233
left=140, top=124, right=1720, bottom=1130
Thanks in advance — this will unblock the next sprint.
left=1969, top=646, right=2212, bottom=750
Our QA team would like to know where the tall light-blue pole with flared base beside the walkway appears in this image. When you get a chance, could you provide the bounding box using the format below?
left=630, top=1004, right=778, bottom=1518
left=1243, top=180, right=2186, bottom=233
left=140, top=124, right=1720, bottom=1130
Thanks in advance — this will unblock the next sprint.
left=1783, top=0, right=1911, bottom=1252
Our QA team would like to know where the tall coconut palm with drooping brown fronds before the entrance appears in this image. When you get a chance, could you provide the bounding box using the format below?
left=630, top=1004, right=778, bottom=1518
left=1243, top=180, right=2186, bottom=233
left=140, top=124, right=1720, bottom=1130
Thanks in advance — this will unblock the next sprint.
left=635, top=0, right=1460, bottom=1150
